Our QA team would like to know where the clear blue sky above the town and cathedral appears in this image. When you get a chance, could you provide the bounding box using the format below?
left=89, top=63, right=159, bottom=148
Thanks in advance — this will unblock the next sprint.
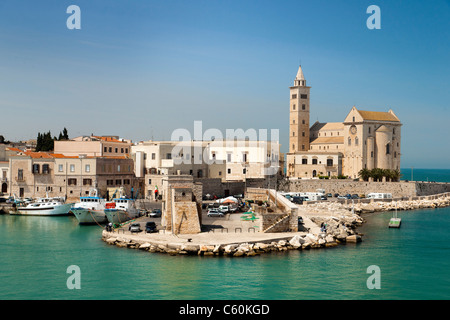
left=0, top=0, right=450, bottom=169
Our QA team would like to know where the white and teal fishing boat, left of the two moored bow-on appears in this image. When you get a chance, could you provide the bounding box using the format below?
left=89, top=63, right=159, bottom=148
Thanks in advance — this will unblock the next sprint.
left=71, top=188, right=108, bottom=224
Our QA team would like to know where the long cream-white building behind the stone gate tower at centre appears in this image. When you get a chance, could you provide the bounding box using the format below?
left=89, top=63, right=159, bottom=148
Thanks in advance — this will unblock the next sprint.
left=131, top=140, right=282, bottom=198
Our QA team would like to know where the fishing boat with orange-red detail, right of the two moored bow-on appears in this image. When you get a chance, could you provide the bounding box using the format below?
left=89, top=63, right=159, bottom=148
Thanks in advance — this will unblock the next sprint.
left=104, top=188, right=139, bottom=225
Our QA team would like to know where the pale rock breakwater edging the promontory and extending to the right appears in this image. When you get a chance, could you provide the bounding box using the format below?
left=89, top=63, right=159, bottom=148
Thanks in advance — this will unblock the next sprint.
left=102, top=193, right=450, bottom=257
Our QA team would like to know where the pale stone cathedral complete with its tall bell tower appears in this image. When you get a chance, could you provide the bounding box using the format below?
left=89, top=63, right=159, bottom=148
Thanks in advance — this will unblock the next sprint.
left=286, top=66, right=402, bottom=178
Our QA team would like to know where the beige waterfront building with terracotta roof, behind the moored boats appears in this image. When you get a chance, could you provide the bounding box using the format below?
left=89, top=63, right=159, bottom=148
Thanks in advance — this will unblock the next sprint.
left=9, top=152, right=139, bottom=201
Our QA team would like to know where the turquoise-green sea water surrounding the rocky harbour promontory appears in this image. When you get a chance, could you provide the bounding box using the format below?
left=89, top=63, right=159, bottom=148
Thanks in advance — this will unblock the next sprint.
left=0, top=169, right=450, bottom=300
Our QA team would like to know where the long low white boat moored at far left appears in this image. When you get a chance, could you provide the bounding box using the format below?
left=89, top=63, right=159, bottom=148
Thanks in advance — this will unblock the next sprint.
left=10, top=196, right=72, bottom=216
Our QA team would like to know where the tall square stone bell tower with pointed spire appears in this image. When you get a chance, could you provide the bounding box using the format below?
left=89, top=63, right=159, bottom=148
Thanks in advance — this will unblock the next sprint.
left=289, top=66, right=311, bottom=153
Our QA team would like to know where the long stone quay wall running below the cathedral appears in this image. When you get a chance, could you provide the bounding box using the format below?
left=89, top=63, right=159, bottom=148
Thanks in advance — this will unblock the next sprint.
left=279, top=179, right=450, bottom=198
